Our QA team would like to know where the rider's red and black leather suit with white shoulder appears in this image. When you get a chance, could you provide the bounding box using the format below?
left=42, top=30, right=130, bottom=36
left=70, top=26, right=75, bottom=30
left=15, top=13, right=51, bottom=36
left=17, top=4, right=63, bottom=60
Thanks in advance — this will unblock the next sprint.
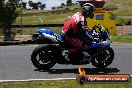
left=62, top=12, right=92, bottom=53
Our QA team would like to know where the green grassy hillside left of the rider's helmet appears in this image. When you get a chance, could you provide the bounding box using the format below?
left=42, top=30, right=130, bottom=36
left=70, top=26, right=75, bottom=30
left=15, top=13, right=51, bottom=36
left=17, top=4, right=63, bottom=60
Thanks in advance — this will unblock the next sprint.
left=14, top=4, right=80, bottom=25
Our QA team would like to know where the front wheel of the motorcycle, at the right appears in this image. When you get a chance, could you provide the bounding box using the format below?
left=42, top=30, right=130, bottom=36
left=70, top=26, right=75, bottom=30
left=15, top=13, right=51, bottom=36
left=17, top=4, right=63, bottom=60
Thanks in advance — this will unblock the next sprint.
left=91, top=47, right=114, bottom=68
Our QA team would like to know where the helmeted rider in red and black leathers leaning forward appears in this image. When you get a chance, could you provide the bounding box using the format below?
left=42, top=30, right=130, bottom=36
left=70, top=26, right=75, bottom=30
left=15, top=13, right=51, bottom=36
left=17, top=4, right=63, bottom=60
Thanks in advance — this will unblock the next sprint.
left=62, top=3, right=95, bottom=53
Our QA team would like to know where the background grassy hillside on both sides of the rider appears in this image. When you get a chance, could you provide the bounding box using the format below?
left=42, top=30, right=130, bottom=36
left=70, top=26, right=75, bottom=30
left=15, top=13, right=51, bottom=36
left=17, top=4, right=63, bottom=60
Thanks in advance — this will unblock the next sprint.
left=14, top=0, right=132, bottom=25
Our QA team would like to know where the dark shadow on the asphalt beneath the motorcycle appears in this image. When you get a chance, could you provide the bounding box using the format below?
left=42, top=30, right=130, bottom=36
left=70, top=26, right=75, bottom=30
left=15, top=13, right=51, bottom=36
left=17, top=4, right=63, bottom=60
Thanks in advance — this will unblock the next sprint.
left=35, top=68, right=120, bottom=74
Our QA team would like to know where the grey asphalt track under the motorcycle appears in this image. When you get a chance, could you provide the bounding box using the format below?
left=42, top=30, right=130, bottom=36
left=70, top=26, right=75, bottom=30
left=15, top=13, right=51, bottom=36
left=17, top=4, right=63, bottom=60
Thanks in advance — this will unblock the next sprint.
left=0, top=44, right=132, bottom=81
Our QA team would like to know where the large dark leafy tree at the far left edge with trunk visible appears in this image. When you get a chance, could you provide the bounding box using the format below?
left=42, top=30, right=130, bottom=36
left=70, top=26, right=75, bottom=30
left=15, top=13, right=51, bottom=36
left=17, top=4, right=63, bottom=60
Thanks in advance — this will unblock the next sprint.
left=0, top=0, right=19, bottom=41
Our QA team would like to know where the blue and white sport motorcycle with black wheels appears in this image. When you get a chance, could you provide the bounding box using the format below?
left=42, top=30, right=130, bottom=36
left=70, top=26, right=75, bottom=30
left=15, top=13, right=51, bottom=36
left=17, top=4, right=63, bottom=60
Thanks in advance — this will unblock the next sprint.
left=31, top=26, right=114, bottom=70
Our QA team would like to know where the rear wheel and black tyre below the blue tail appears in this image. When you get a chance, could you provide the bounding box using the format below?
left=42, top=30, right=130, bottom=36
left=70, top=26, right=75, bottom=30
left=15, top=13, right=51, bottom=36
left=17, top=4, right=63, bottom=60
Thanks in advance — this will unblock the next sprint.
left=31, top=45, right=56, bottom=70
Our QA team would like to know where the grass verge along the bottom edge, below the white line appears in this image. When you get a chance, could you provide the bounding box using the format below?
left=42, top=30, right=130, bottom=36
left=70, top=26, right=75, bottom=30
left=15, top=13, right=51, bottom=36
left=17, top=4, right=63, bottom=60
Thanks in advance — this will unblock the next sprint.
left=0, top=80, right=132, bottom=88
